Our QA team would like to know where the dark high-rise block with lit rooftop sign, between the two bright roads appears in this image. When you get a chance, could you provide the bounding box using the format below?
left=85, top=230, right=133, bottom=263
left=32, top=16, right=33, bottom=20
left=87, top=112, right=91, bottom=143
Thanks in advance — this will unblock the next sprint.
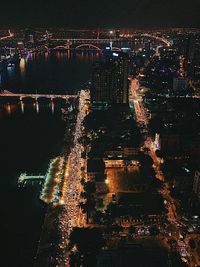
left=91, top=52, right=129, bottom=108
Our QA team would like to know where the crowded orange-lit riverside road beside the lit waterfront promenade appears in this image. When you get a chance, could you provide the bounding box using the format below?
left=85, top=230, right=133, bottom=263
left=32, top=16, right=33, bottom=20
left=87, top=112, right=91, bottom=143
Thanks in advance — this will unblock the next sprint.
left=57, top=90, right=89, bottom=266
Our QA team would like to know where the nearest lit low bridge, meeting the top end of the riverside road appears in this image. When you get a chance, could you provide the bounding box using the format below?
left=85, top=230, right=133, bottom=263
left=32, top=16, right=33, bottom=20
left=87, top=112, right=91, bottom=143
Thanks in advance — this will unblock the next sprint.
left=0, top=90, right=78, bottom=100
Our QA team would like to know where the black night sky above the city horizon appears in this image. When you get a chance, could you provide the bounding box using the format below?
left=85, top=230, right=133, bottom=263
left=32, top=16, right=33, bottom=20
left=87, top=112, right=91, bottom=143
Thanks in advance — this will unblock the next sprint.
left=0, top=0, right=200, bottom=28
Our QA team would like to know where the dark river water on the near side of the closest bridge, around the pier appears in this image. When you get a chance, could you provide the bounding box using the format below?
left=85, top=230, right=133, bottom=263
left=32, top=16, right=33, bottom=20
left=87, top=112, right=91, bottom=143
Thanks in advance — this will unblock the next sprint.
left=0, top=105, right=65, bottom=266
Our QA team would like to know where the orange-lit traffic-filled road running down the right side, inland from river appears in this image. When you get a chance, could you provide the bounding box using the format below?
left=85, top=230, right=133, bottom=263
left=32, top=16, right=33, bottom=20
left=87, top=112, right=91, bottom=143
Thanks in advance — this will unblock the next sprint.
left=130, top=79, right=200, bottom=267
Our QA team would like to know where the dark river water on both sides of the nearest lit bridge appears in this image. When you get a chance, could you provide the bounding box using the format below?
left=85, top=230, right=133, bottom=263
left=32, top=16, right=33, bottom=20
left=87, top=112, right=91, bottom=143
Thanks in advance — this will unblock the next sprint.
left=0, top=53, right=98, bottom=267
